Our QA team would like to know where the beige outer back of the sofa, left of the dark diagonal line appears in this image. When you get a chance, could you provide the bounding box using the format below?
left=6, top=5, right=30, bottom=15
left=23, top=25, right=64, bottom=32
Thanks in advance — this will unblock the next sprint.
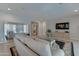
left=14, top=39, right=38, bottom=56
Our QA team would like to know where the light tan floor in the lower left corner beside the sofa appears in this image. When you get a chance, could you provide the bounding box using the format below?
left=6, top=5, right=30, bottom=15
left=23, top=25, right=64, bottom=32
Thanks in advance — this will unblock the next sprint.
left=0, top=40, right=13, bottom=56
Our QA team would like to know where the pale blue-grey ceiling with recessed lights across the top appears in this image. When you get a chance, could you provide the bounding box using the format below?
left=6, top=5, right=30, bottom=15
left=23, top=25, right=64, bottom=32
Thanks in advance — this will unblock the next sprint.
left=0, top=3, right=79, bottom=21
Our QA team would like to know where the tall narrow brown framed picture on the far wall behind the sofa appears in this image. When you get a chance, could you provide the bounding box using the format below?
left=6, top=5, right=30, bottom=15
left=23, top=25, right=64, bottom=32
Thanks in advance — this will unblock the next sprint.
left=31, top=22, right=38, bottom=39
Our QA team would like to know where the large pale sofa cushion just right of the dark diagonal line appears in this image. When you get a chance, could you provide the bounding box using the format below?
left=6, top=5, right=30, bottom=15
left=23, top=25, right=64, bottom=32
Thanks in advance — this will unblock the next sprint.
left=28, top=40, right=52, bottom=56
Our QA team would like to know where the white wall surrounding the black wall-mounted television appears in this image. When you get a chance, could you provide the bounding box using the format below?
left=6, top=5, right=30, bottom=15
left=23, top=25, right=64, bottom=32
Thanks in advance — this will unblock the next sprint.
left=49, top=15, right=79, bottom=40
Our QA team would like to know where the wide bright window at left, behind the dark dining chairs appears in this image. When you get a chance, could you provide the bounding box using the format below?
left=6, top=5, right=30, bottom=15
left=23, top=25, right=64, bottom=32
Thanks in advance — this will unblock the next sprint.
left=4, top=24, right=28, bottom=35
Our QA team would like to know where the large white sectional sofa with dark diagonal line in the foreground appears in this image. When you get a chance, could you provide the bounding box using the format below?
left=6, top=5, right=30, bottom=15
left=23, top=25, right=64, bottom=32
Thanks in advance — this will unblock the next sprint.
left=14, top=35, right=65, bottom=56
